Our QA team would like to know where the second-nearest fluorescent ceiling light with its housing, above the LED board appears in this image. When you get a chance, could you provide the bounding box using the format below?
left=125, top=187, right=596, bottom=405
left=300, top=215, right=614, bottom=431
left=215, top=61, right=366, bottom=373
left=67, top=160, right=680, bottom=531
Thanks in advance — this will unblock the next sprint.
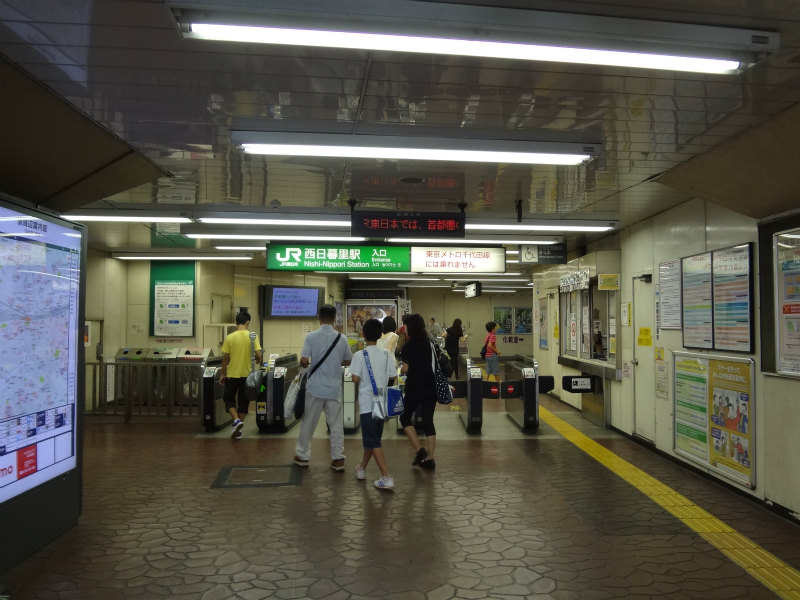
left=231, top=130, right=602, bottom=165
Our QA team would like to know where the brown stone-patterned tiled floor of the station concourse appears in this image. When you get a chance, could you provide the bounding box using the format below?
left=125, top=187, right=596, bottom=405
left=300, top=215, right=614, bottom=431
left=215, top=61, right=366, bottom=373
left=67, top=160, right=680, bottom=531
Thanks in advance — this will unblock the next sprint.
left=2, top=397, right=800, bottom=600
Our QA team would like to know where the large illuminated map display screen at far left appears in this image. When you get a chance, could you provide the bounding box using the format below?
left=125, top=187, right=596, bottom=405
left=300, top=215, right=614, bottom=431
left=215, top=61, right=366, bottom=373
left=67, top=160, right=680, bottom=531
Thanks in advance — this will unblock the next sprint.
left=0, top=204, right=83, bottom=503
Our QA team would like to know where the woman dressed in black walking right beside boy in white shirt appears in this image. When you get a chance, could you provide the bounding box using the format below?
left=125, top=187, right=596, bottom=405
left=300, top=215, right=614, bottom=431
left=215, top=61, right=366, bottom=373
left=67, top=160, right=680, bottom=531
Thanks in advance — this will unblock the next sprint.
left=400, top=313, right=436, bottom=469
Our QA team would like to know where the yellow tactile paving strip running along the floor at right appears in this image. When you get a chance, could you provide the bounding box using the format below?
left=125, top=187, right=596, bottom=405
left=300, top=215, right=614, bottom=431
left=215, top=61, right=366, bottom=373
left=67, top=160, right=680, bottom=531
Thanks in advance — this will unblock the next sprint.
left=539, top=407, right=800, bottom=600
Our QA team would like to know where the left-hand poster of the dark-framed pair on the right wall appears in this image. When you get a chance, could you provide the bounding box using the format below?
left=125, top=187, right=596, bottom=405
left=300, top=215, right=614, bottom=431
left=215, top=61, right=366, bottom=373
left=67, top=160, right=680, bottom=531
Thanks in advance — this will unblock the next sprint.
left=681, top=252, right=714, bottom=348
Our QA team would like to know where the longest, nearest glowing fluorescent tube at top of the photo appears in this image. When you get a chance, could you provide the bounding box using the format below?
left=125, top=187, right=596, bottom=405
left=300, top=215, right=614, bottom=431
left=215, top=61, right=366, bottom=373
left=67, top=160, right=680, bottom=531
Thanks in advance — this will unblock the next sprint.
left=189, top=23, right=740, bottom=74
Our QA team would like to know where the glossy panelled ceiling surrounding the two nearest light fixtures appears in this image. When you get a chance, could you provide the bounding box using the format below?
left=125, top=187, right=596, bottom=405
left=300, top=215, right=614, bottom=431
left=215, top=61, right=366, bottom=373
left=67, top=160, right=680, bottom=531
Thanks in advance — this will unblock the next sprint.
left=0, top=0, right=800, bottom=268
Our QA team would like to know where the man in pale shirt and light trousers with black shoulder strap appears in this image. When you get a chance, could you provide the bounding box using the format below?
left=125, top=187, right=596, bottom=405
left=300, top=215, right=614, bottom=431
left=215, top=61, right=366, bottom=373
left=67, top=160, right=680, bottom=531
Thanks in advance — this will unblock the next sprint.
left=294, top=304, right=353, bottom=472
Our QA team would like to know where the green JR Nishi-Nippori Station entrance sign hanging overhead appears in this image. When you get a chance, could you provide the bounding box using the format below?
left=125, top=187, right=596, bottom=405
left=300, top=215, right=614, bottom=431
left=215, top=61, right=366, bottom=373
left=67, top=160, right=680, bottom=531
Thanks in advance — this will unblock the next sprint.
left=267, top=244, right=411, bottom=273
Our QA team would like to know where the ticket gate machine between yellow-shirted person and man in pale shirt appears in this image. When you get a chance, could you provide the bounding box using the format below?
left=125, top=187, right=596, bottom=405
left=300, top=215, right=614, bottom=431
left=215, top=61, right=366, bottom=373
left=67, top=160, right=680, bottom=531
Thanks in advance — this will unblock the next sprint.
left=255, top=354, right=300, bottom=433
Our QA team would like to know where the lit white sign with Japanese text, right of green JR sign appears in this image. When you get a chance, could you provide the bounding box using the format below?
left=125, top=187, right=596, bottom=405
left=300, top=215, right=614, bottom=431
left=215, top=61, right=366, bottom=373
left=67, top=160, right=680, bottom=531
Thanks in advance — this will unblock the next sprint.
left=411, top=246, right=506, bottom=275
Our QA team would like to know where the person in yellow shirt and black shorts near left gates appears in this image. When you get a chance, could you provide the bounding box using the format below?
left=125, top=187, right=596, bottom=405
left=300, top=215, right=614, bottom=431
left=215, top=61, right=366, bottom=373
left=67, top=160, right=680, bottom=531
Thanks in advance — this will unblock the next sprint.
left=219, top=311, right=261, bottom=440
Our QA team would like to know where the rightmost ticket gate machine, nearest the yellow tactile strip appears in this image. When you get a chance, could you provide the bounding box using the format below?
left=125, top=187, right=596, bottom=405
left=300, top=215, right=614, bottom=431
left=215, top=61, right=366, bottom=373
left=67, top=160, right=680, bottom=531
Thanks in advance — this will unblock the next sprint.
left=501, top=360, right=554, bottom=433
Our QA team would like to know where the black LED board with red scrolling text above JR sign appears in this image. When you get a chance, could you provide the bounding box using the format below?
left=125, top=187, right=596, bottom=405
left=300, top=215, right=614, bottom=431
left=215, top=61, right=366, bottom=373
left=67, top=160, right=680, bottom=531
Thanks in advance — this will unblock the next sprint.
left=350, top=211, right=466, bottom=239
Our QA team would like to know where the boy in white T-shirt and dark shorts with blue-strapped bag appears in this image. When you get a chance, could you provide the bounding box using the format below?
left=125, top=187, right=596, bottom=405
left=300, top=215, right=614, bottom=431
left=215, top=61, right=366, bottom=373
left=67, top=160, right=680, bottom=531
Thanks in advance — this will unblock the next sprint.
left=350, top=319, right=397, bottom=490
